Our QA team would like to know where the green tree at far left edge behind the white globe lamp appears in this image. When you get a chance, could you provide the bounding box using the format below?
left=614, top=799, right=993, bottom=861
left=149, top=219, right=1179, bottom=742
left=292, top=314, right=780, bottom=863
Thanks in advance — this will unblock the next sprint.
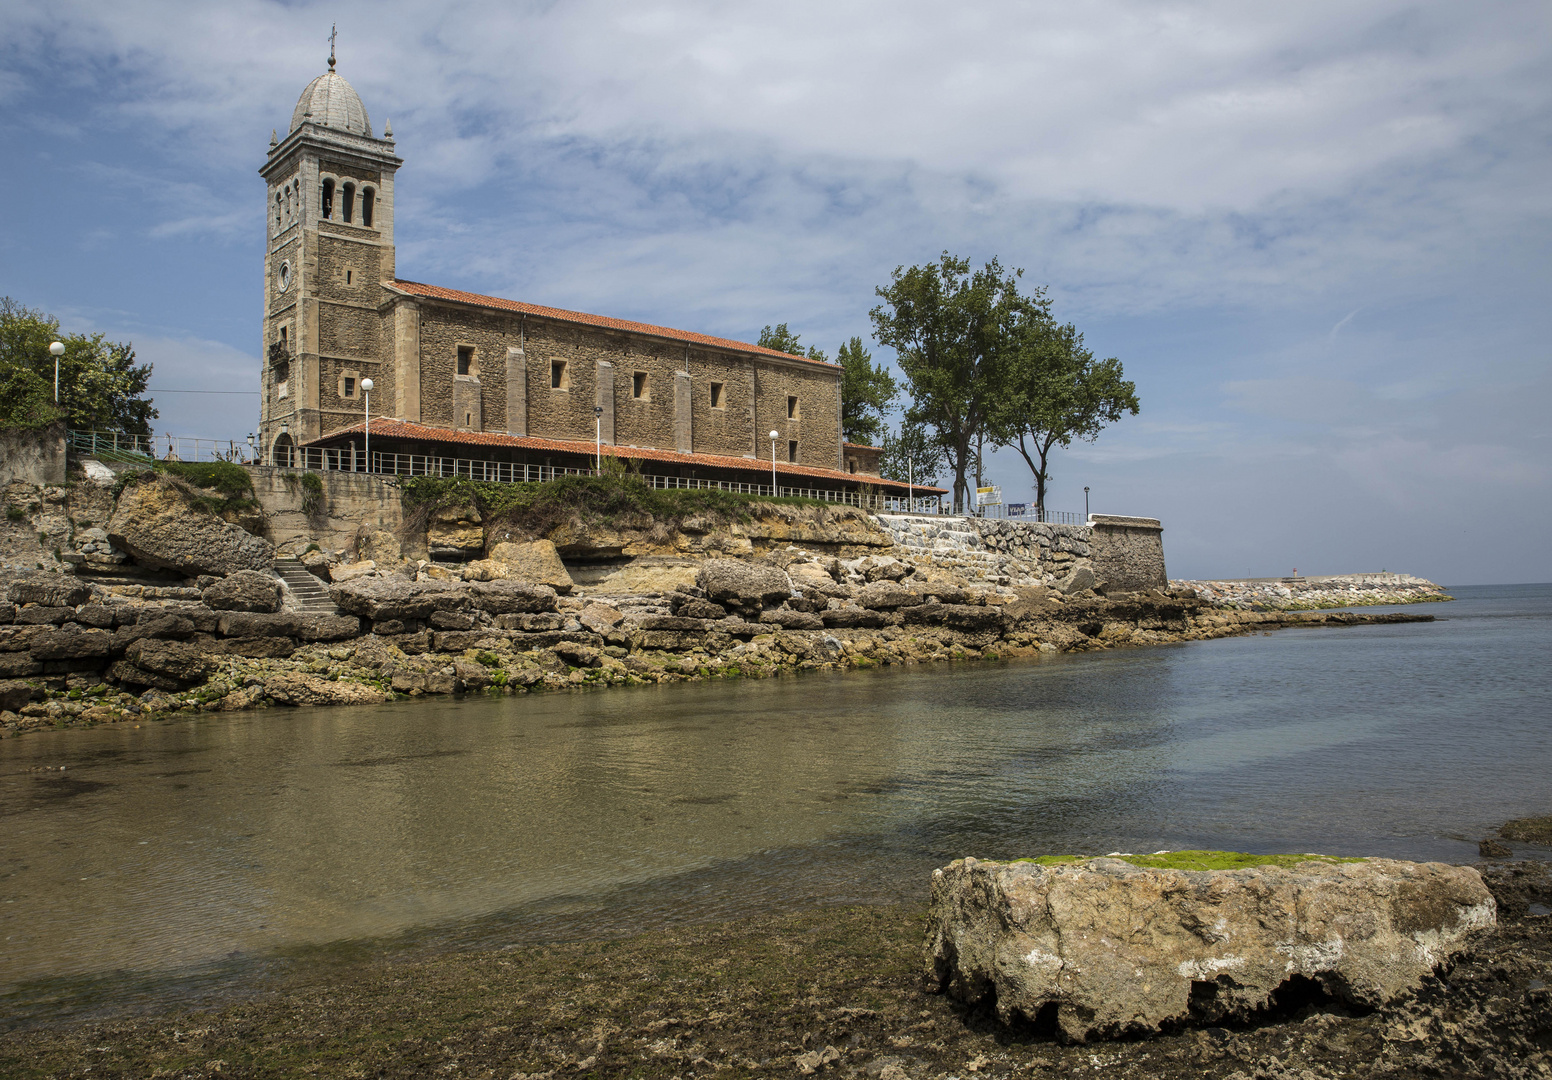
left=0, top=296, right=157, bottom=434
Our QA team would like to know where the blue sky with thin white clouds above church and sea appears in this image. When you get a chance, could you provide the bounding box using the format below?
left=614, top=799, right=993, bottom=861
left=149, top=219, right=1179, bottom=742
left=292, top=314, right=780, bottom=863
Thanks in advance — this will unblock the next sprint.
left=0, top=0, right=1552, bottom=585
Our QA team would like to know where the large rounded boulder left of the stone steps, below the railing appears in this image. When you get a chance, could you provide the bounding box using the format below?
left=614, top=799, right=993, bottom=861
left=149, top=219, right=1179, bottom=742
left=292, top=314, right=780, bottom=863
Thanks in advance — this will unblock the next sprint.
left=107, top=483, right=275, bottom=577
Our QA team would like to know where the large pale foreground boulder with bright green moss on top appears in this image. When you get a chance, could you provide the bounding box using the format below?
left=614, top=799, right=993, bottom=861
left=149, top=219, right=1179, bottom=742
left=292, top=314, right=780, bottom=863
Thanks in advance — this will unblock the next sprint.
left=927, top=858, right=1496, bottom=1041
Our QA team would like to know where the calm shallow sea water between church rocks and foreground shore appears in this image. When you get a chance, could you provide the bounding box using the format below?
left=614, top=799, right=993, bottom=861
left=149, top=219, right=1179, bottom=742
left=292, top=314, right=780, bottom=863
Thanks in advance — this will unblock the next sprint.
left=0, top=585, right=1552, bottom=1024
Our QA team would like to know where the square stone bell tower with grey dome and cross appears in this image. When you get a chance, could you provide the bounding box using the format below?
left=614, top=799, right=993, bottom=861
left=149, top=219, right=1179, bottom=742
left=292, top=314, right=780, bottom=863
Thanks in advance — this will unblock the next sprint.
left=259, top=43, right=404, bottom=464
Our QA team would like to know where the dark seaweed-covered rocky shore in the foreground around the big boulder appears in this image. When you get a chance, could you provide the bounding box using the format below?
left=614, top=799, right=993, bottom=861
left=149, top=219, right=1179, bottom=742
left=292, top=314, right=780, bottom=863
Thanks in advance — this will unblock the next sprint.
left=0, top=863, right=1552, bottom=1080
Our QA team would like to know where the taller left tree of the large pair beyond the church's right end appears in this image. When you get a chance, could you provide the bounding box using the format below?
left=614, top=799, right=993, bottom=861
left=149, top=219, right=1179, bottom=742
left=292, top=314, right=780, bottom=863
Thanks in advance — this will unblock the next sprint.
left=869, top=251, right=1049, bottom=509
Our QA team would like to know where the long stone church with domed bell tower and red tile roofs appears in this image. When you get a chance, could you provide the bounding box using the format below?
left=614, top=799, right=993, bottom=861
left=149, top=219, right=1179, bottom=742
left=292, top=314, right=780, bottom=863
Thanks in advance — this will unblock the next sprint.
left=259, top=56, right=923, bottom=495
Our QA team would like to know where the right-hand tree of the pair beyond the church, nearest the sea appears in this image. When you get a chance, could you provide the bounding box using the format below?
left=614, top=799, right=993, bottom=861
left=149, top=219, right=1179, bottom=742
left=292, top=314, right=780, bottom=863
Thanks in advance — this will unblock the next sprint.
left=987, top=323, right=1139, bottom=517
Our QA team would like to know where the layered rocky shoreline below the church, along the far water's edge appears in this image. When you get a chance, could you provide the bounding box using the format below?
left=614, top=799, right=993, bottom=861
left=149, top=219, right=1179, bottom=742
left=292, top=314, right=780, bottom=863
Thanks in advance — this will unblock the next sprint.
left=0, top=549, right=1431, bottom=734
